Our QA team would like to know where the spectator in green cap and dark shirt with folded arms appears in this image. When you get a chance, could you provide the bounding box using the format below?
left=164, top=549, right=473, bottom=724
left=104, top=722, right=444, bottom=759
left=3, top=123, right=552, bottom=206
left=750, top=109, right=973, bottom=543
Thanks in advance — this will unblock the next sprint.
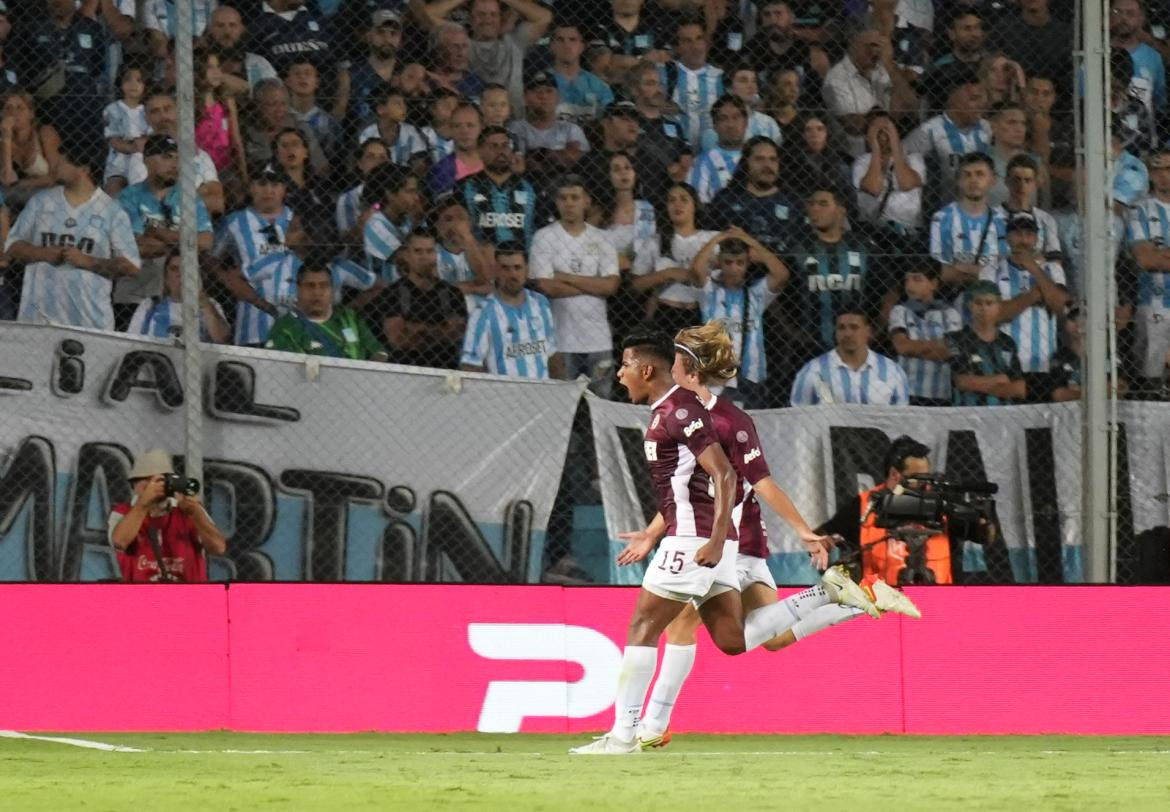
left=944, top=280, right=1027, bottom=406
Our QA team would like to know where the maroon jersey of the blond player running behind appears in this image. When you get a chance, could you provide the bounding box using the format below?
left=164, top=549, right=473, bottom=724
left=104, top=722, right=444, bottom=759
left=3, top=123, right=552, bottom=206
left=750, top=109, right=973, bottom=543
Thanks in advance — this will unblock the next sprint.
left=708, top=398, right=771, bottom=558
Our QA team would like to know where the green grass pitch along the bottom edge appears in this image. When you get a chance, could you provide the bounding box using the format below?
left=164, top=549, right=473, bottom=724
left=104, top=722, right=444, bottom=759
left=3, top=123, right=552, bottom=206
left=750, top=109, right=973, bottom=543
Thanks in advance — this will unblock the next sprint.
left=0, top=732, right=1170, bottom=812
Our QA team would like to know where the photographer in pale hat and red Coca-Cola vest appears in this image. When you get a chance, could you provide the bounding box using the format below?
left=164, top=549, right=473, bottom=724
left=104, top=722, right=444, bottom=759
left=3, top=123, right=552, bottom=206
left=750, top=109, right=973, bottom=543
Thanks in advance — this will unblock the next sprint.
left=106, top=448, right=227, bottom=584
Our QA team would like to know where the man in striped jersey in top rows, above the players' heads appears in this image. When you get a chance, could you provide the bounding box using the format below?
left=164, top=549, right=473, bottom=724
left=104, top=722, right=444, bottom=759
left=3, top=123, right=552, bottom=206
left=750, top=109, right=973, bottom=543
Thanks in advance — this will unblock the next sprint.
left=662, top=19, right=720, bottom=149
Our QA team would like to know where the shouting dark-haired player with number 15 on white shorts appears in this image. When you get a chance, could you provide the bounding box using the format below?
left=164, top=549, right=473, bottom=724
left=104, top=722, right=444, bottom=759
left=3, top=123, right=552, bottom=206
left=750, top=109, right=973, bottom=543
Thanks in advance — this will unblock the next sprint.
left=570, top=333, right=878, bottom=755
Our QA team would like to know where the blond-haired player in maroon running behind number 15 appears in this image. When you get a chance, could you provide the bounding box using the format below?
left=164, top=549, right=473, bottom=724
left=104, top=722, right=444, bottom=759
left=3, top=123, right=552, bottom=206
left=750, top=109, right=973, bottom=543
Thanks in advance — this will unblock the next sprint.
left=618, top=321, right=918, bottom=750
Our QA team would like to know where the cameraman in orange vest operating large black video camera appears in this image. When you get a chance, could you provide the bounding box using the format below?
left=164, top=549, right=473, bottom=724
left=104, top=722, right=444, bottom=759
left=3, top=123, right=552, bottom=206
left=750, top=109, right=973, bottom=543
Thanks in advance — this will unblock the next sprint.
left=817, top=434, right=1012, bottom=585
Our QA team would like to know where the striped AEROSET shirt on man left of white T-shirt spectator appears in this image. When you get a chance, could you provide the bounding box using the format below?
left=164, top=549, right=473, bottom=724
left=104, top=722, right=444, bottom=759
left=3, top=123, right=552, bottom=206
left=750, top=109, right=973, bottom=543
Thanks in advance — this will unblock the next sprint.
left=460, top=290, right=557, bottom=380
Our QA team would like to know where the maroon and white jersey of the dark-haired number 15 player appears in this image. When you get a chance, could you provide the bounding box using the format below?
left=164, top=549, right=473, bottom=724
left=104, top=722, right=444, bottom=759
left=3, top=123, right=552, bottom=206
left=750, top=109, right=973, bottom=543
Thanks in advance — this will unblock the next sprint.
left=644, top=386, right=736, bottom=539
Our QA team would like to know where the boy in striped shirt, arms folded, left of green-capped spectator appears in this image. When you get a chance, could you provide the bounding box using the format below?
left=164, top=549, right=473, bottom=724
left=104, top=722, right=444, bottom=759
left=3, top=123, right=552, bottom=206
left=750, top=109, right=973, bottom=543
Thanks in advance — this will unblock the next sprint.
left=889, top=256, right=963, bottom=406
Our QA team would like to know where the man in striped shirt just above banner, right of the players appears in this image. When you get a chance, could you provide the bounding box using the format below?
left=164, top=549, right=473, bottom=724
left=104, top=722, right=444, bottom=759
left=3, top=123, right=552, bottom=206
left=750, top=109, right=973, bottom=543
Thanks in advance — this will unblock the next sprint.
left=791, top=308, right=910, bottom=406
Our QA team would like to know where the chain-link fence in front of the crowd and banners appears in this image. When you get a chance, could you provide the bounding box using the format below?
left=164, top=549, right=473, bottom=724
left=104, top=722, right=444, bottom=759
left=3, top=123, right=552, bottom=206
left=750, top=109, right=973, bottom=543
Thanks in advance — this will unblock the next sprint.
left=0, top=0, right=1170, bottom=583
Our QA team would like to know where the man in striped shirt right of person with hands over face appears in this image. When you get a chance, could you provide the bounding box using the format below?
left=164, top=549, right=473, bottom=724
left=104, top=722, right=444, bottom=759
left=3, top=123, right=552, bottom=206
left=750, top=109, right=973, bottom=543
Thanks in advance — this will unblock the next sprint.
left=903, top=70, right=995, bottom=206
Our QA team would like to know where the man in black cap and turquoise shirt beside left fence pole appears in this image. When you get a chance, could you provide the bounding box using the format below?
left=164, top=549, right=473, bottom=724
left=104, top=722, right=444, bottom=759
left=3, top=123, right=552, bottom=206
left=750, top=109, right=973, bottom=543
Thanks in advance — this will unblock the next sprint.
left=113, top=132, right=212, bottom=330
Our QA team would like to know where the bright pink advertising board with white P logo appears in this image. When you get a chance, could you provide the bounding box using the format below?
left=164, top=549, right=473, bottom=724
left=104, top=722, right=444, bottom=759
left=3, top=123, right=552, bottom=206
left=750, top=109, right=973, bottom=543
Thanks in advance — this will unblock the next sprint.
left=0, top=584, right=1170, bottom=735
